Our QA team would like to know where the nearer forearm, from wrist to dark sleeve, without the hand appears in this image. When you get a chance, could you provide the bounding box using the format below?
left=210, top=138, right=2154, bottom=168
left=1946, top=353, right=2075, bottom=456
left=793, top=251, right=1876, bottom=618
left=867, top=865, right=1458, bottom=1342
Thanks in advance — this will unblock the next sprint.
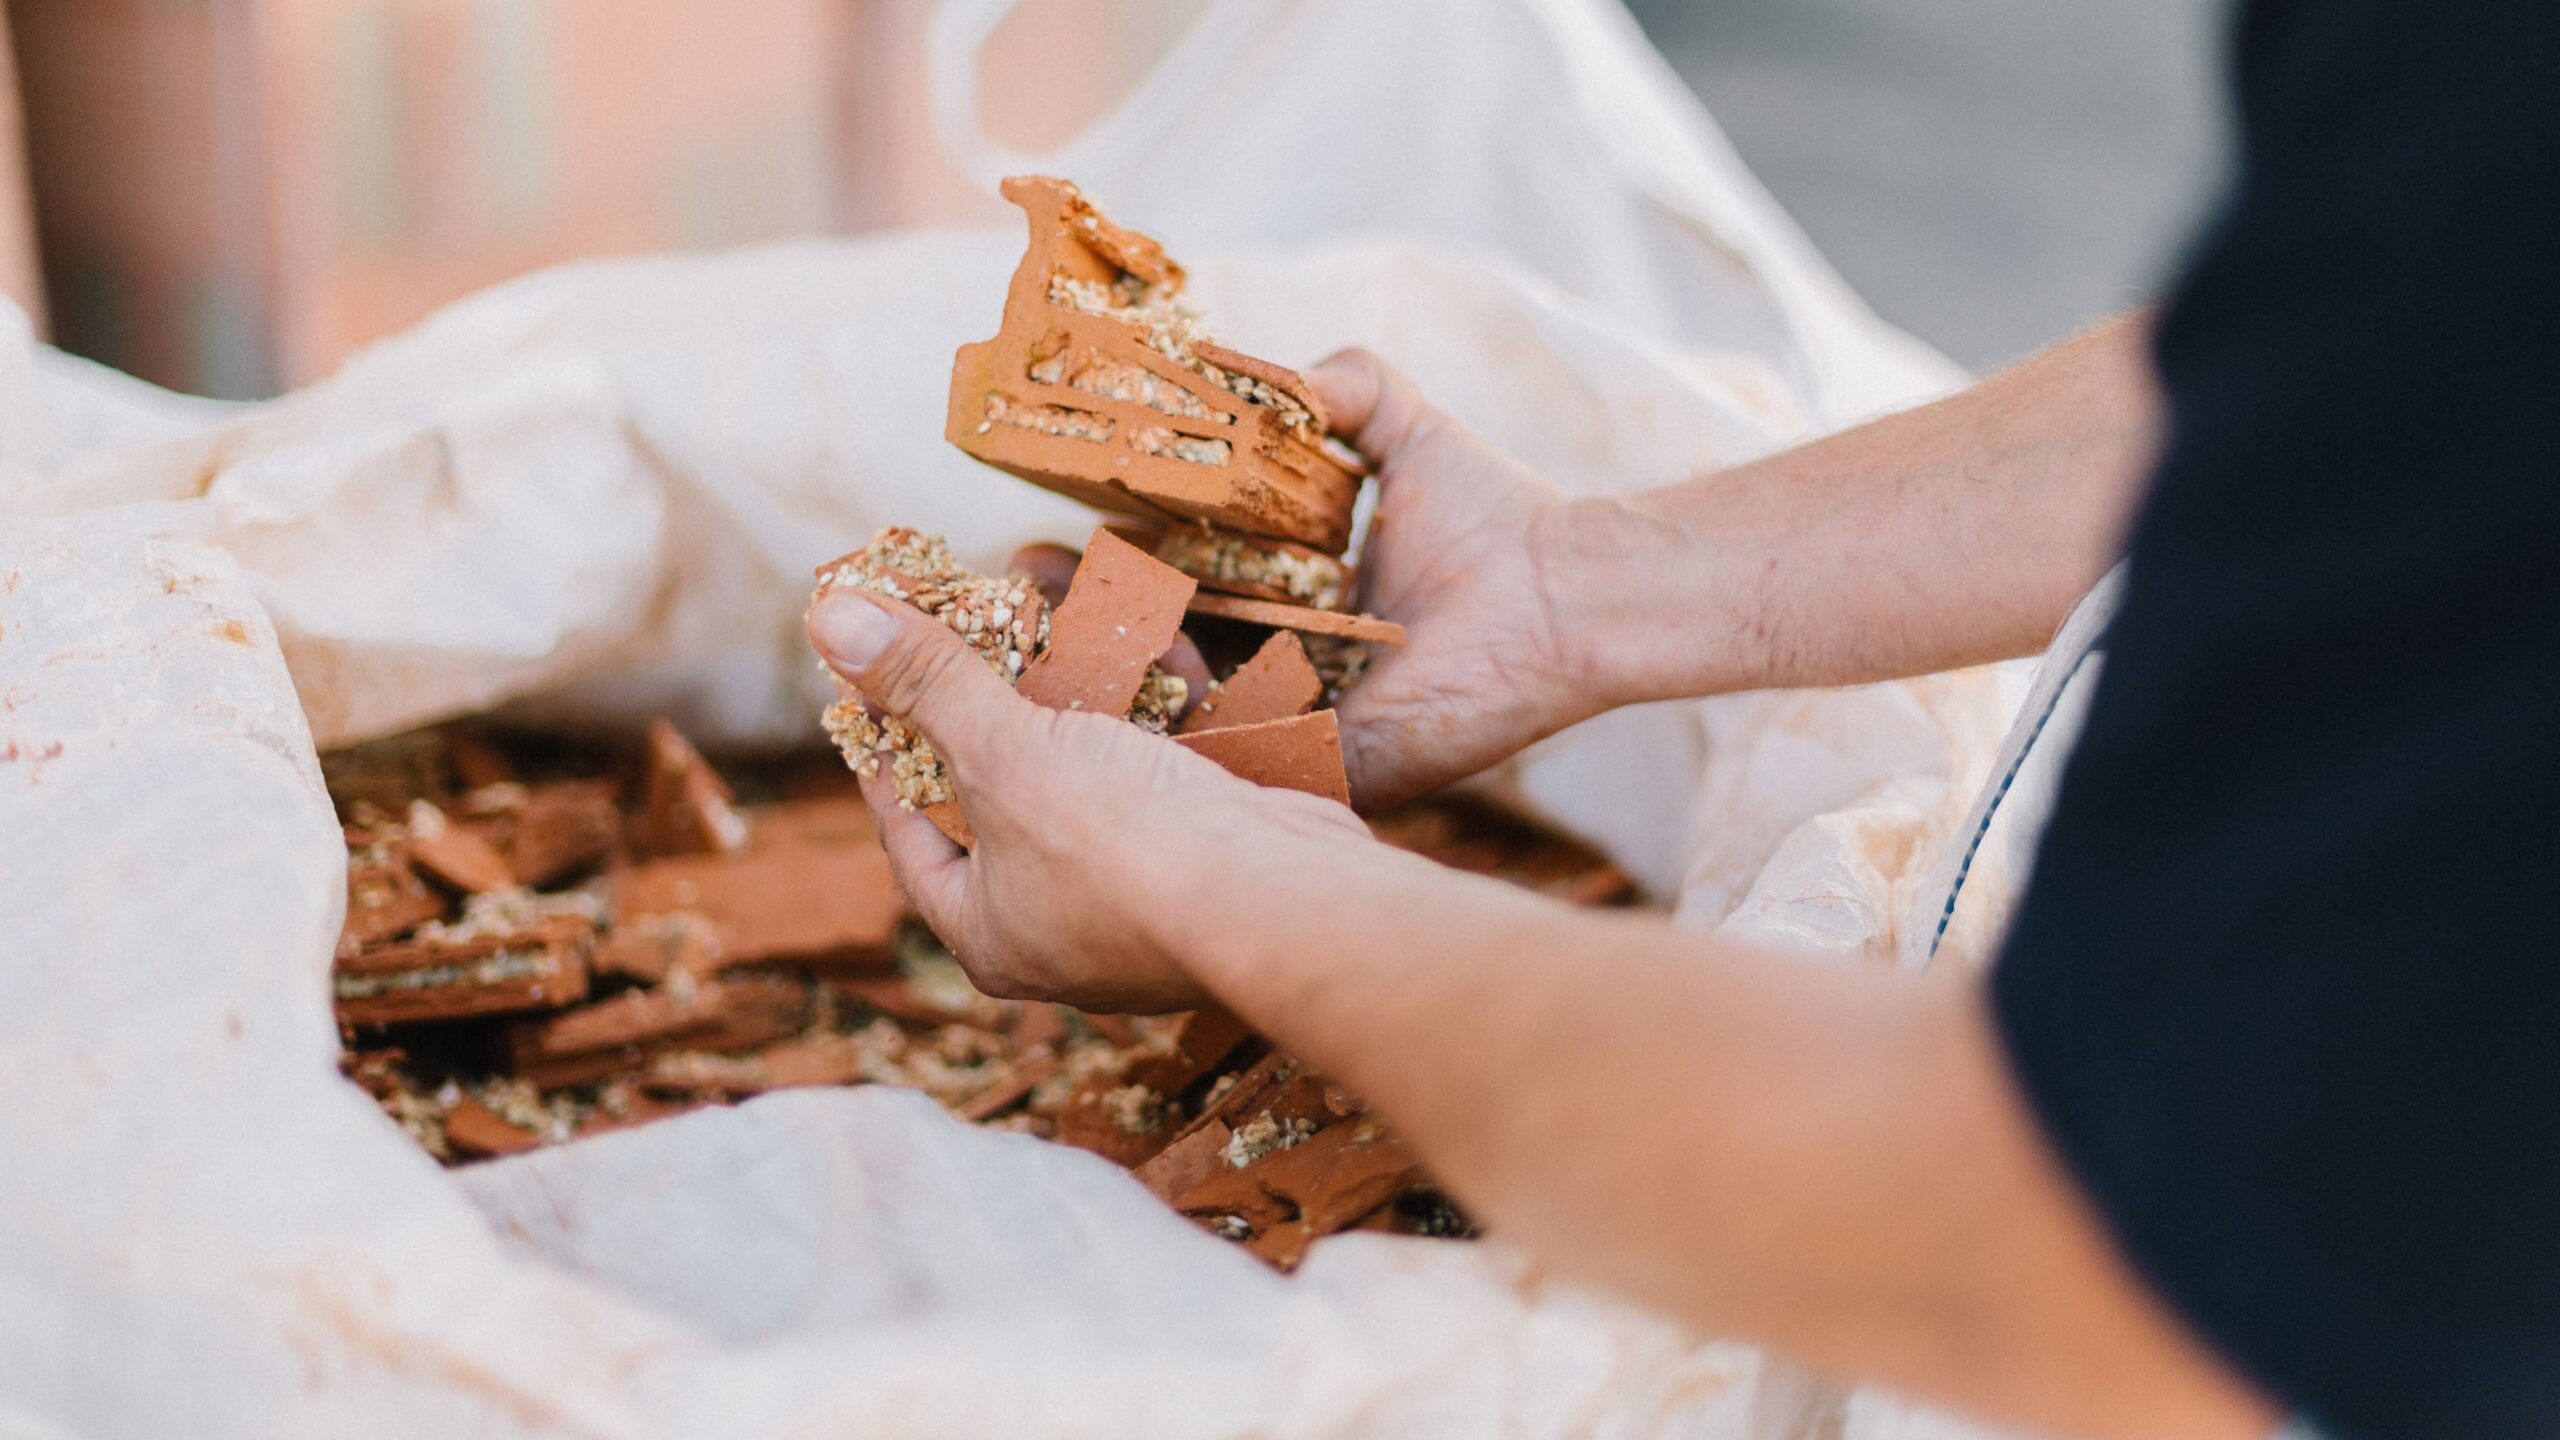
left=1188, top=835, right=2263, bottom=1437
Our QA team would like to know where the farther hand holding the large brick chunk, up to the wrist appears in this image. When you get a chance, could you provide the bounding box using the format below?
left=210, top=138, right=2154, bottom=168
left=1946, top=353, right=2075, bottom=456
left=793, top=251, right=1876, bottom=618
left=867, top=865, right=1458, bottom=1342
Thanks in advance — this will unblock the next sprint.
left=1306, top=348, right=1605, bottom=810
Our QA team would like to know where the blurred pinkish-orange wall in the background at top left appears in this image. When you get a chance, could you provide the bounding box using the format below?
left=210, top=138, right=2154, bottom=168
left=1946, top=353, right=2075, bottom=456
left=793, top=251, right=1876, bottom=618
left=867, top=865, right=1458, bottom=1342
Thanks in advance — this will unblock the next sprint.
left=10, top=0, right=847, bottom=395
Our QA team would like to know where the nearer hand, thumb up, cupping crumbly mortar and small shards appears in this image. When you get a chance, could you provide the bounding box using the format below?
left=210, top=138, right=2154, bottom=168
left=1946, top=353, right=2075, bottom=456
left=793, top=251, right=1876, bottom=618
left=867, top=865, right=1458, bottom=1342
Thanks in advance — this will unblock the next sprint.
left=809, top=589, right=1375, bottom=1015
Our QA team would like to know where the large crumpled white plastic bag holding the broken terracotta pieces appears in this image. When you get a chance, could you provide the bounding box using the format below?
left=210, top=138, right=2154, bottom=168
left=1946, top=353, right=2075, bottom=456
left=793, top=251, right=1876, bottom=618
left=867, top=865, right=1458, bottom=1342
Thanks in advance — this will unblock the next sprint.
left=0, top=3, right=2037, bottom=1440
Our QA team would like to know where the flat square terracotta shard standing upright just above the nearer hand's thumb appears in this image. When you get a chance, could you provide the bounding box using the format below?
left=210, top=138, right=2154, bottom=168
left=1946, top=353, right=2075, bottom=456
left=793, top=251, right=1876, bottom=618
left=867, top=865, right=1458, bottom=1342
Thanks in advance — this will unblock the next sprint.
left=1016, top=530, right=1198, bottom=717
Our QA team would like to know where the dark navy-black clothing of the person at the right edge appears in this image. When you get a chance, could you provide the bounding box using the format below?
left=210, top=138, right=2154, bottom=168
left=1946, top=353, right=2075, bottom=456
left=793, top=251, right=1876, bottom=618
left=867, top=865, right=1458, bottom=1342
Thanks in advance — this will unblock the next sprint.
left=1992, top=0, right=2560, bottom=1440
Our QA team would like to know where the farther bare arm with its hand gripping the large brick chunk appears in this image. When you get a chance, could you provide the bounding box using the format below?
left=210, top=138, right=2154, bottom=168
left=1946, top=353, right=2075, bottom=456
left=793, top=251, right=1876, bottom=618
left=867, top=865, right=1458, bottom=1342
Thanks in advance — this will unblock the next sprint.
left=1311, top=315, right=2161, bottom=805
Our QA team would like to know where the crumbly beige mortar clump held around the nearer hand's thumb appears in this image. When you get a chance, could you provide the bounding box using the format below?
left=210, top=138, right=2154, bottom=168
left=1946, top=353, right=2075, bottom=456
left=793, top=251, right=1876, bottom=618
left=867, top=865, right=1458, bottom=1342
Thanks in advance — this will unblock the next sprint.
left=812, top=525, right=1190, bottom=810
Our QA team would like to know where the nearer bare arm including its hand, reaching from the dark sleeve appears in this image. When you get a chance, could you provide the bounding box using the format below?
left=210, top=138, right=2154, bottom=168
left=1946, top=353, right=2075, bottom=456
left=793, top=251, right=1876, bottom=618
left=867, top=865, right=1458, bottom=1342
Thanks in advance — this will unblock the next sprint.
left=812, top=594, right=2271, bottom=1440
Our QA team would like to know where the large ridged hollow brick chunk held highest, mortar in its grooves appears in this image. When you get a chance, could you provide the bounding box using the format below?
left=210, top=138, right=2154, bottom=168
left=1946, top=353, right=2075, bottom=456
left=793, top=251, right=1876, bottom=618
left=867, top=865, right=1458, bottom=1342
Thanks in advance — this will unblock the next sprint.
left=947, top=177, right=1362, bottom=556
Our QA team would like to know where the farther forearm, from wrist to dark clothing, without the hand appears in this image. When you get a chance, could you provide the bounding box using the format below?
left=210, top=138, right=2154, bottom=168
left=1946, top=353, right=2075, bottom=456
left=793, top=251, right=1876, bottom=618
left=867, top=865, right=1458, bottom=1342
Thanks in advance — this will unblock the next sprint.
left=1539, top=315, right=2161, bottom=705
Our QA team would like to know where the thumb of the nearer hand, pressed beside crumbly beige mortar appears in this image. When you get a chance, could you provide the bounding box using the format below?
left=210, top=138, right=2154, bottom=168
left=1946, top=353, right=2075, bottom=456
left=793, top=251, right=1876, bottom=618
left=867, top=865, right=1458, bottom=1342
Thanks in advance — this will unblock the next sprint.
left=809, top=589, right=1029, bottom=771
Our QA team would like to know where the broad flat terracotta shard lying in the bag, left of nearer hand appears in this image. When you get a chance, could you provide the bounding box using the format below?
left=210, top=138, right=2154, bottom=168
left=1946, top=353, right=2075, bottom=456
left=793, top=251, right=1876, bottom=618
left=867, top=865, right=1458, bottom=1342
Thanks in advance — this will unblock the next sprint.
left=612, top=819, right=906, bottom=969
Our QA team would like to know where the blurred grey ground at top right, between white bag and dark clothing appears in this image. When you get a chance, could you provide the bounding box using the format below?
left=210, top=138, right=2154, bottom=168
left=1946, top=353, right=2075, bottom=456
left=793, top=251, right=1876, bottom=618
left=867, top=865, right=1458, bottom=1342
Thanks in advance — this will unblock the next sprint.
left=1628, top=0, right=2227, bottom=366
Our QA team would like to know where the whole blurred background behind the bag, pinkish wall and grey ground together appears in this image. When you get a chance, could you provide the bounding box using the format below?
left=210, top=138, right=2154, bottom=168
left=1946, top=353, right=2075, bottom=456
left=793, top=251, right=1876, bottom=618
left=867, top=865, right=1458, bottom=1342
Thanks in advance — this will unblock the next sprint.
left=0, top=0, right=2225, bottom=397
